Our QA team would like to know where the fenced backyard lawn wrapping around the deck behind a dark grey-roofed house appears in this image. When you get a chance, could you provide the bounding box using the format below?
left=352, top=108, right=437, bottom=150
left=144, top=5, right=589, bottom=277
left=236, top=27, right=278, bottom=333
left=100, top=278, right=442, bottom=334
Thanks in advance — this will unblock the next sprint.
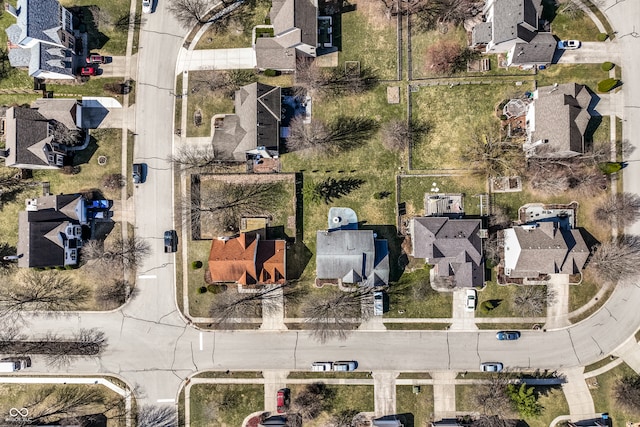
left=400, top=175, right=486, bottom=215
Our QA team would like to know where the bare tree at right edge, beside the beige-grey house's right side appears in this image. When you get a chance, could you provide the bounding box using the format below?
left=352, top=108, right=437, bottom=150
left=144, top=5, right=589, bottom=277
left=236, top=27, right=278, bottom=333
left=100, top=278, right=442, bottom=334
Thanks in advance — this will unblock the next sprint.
left=589, top=236, right=640, bottom=283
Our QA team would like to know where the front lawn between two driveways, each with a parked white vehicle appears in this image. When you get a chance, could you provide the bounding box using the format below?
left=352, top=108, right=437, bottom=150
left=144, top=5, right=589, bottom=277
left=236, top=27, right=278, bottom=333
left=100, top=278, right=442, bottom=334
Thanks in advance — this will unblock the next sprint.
left=385, top=268, right=453, bottom=318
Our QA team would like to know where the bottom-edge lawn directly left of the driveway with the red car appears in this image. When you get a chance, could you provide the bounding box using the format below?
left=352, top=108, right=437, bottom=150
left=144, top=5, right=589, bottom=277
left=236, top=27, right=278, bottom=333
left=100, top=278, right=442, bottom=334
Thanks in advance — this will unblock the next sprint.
left=190, top=384, right=264, bottom=427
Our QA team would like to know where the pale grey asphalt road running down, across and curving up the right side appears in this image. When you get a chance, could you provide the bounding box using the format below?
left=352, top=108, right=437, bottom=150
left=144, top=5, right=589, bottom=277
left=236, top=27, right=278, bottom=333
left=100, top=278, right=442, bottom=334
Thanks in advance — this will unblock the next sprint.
left=15, top=0, right=640, bottom=412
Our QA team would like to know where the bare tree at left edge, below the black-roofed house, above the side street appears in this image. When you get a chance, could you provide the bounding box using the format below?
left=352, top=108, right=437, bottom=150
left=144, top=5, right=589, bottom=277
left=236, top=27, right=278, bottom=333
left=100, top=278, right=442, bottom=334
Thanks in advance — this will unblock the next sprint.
left=0, top=270, right=90, bottom=316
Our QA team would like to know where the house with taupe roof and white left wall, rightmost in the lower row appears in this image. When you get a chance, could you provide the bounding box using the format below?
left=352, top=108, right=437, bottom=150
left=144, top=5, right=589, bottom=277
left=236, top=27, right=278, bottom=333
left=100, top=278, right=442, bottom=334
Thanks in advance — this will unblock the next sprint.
left=503, top=221, right=590, bottom=279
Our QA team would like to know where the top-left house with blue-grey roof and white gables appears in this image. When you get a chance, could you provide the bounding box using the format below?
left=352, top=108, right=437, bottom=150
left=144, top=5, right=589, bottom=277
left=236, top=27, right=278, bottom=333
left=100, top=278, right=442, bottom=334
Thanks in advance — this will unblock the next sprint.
left=6, top=0, right=75, bottom=79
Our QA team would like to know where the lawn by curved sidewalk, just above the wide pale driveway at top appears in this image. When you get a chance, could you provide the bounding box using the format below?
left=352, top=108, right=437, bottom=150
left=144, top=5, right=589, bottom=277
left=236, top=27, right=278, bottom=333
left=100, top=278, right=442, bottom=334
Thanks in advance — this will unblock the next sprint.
left=195, top=0, right=271, bottom=49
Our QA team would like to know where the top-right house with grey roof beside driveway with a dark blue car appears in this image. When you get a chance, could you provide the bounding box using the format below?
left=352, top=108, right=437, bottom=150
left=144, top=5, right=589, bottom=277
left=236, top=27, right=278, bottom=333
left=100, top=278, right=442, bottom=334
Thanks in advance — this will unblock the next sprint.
left=471, top=0, right=557, bottom=67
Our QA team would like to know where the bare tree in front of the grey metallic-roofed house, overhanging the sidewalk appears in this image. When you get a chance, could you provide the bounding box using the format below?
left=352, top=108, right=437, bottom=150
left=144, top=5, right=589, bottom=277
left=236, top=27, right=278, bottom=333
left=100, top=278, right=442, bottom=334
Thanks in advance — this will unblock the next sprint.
left=302, top=286, right=373, bottom=343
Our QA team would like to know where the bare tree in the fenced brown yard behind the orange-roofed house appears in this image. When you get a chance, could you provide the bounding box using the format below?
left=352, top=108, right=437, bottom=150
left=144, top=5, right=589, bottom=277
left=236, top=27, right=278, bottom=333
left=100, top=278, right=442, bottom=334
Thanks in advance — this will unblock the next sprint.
left=186, top=181, right=284, bottom=232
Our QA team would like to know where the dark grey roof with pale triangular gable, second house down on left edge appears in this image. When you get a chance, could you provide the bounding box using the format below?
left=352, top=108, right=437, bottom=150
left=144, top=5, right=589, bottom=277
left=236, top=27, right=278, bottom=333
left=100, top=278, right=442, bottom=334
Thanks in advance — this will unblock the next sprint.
left=5, top=107, right=53, bottom=166
